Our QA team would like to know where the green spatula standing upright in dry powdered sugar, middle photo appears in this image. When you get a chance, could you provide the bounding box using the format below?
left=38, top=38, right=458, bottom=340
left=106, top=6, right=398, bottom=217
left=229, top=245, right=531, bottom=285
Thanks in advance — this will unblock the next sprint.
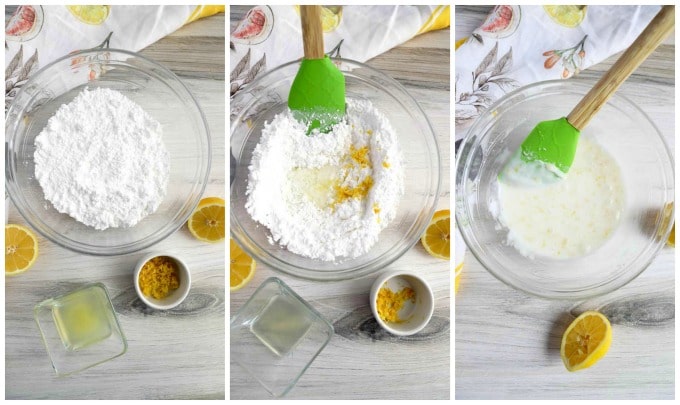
left=288, top=6, right=345, bottom=134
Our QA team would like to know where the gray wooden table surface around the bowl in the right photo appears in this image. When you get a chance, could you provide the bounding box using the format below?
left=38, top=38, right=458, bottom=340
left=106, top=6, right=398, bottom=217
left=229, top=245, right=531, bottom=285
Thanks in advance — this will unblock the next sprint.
left=454, top=6, right=675, bottom=399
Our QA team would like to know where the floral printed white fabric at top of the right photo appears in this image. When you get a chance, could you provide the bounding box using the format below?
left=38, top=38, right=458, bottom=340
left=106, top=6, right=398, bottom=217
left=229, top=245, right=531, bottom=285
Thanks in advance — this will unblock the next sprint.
left=455, top=6, right=660, bottom=139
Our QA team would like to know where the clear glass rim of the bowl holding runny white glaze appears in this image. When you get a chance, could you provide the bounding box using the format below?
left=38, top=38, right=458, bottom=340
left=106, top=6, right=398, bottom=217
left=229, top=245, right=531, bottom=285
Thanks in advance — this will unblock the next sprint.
left=454, top=79, right=675, bottom=301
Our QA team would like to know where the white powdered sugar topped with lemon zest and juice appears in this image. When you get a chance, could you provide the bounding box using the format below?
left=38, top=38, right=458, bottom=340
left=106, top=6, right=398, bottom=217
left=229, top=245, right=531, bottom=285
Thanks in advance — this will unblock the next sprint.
left=246, top=99, right=404, bottom=261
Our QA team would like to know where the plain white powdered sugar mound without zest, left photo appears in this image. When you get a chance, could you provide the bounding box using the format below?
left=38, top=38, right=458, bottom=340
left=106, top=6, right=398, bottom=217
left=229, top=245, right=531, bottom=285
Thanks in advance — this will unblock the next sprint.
left=34, top=88, right=170, bottom=230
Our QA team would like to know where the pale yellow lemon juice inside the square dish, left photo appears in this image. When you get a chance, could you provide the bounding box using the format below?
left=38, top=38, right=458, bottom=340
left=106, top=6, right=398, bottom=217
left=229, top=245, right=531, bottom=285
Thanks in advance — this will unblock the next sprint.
left=52, top=289, right=113, bottom=351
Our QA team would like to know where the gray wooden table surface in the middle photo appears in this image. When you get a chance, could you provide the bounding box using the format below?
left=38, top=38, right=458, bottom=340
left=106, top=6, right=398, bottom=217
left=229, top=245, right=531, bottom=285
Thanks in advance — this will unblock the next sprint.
left=229, top=6, right=451, bottom=399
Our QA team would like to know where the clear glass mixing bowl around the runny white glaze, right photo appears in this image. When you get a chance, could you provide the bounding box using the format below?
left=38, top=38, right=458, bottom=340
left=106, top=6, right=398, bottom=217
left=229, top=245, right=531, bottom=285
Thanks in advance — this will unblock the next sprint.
left=456, top=80, right=675, bottom=299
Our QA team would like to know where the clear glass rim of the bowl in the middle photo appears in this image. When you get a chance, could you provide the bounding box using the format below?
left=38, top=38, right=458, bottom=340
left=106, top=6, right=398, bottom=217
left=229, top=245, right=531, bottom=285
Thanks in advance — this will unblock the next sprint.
left=229, top=58, right=443, bottom=282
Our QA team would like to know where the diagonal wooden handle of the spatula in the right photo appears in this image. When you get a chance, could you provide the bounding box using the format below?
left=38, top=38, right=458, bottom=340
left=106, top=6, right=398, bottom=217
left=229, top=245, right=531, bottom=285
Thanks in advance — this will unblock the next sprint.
left=567, top=6, right=675, bottom=130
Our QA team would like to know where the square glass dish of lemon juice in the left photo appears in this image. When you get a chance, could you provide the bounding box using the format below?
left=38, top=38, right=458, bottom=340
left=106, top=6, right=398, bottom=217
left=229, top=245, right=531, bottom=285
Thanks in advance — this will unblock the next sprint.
left=33, top=283, right=127, bottom=376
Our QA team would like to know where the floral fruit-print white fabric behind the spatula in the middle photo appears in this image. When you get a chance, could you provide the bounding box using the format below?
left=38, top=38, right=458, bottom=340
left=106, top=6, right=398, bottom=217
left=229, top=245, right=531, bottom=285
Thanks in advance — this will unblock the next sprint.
left=229, top=6, right=450, bottom=95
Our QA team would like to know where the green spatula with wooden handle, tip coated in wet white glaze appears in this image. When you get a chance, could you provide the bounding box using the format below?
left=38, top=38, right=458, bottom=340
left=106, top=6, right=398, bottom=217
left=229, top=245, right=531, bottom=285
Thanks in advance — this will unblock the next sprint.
left=499, top=6, right=675, bottom=185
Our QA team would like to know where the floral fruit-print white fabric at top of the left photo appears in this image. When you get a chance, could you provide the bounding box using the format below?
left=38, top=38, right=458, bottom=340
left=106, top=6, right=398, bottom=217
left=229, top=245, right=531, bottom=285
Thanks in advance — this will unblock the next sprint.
left=5, top=5, right=225, bottom=109
